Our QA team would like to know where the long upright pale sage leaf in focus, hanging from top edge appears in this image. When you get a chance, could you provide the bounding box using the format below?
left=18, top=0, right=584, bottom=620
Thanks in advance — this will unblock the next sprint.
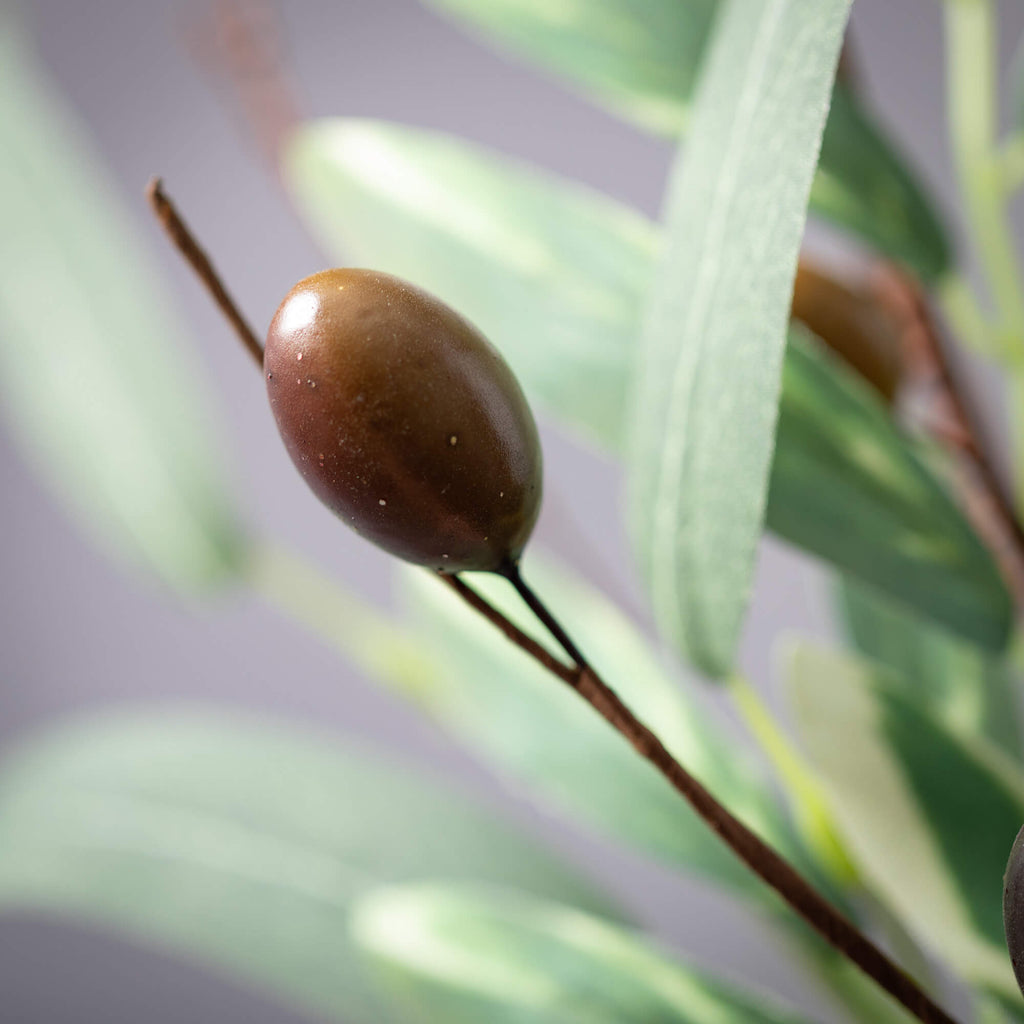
left=629, top=0, right=849, bottom=677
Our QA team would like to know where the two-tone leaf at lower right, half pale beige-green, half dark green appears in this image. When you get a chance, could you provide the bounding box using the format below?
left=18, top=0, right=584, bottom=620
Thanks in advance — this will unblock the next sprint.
left=790, top=645, right=1024, bottom=1001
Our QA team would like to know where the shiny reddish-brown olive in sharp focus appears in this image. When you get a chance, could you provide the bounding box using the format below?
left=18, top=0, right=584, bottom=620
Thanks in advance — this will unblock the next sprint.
left=263, top=268, right=542, bottom=572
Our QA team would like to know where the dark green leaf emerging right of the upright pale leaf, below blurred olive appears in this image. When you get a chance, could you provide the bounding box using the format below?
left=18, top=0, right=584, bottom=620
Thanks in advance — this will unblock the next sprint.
left=767, top=339, right=1013, bottom=650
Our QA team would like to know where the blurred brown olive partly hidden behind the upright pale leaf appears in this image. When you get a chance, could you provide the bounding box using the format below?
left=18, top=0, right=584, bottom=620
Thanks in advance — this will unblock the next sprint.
left=793, top=259, right=902, bottom=401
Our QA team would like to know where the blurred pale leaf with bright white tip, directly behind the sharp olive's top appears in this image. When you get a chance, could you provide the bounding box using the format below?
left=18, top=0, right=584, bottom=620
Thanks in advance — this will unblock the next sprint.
left=284, top=120, right=655, bottom=444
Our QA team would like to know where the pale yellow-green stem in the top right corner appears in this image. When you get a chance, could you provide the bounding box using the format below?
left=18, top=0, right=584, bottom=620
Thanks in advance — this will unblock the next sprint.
left=945, top=0, right=1024, bottom=344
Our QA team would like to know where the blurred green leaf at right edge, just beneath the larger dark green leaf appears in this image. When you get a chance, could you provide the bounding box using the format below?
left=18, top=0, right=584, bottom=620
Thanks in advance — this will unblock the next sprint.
left=839, top=582, right=1021, bottom=757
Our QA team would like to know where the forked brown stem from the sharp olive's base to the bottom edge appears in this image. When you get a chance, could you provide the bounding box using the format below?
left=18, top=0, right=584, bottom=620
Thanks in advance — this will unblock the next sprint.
left=442, top=566, right=954, bottom=1024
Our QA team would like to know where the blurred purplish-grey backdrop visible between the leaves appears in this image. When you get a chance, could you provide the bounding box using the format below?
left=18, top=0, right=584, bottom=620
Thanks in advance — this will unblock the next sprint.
left=0, top=0, right=1024, bottom=1024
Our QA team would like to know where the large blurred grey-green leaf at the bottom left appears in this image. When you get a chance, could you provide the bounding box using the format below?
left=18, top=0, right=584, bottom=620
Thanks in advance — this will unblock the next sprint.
left=0, top=710, right=608, bottom=1024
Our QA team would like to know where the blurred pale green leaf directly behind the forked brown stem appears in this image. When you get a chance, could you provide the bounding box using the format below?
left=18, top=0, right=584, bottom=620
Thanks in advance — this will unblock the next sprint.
left=402, top=556, right=813, bottom=900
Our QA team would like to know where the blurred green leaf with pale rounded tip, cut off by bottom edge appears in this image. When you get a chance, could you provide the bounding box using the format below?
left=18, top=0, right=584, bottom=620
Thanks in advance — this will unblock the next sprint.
left=352, top=886, right=815, bottom=1024
